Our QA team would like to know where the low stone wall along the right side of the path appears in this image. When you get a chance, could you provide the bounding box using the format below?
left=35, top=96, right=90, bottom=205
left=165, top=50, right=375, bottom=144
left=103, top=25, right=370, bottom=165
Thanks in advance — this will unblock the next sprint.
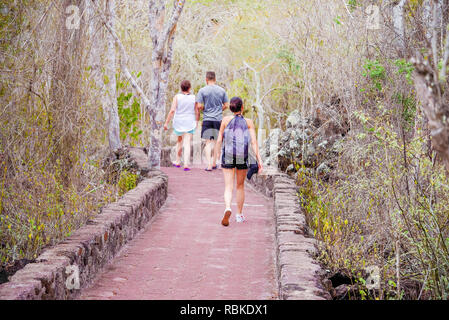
left=250, top=168, right=331, bottom=300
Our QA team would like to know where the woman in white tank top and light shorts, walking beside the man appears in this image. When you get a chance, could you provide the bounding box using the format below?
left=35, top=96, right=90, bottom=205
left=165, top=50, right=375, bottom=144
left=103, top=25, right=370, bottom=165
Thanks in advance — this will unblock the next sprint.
left=164, top=80, right=197, bottom=171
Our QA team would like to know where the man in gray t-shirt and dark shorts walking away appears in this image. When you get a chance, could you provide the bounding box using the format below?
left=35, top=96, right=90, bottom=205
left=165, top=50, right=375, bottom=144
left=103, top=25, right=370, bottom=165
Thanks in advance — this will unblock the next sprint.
left=196, top=71, right=229, bottom=171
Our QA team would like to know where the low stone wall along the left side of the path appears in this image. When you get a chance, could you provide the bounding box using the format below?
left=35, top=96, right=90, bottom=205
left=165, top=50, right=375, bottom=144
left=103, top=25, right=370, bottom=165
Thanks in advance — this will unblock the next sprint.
left=0, top=150, right=168, bottom=300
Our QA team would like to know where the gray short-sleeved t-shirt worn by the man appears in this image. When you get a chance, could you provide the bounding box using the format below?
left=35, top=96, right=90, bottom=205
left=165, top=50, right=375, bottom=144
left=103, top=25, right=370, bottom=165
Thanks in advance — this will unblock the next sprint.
left=196, top=84, right=229, bottom=121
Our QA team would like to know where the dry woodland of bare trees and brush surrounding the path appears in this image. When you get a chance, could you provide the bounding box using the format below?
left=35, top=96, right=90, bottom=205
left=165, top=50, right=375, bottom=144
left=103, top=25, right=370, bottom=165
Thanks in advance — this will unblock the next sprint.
left=0, top=0, right=449, bottom=299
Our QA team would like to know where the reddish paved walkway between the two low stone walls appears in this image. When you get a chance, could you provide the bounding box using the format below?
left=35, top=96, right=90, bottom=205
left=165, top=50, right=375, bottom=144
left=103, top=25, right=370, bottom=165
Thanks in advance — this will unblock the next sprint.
left=81, top=168, right=277, bottom=300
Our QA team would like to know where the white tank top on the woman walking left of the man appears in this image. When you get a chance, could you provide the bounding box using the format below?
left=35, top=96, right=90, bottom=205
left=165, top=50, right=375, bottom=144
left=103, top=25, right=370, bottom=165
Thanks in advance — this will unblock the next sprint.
left=173, top=93, right=196, bottom=132
